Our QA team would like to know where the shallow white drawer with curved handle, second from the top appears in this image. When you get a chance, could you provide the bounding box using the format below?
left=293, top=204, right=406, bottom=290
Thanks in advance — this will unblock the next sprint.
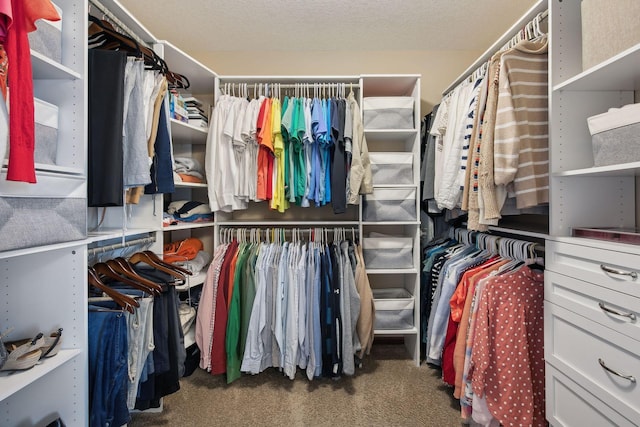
left=544, top=271, right=640, bottom=342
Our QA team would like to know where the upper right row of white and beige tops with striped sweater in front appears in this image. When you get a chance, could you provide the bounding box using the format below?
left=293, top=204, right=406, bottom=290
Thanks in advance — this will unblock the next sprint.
left=427, top=10, right=549, bottom=231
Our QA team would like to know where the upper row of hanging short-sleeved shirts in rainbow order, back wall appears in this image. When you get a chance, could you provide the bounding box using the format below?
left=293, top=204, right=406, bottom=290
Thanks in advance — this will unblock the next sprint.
left=205, top=84, right=373, bottom=214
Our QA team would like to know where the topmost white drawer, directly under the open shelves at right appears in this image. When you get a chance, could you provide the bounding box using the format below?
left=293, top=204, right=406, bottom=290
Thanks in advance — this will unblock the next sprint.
left=545, top=241, right=640, bottom=297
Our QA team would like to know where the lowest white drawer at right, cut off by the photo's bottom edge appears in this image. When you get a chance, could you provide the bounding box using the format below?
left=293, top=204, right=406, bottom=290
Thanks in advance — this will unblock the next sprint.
left=545, top=364, right=638, bottom=427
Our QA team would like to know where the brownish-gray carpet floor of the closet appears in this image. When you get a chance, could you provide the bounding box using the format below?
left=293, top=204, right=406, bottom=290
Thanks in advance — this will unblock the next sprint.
left=129, top=344, right=460, bottom=427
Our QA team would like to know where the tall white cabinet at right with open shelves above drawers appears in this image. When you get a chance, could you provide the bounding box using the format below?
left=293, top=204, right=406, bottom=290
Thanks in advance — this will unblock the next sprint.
left=545, top=0, right=640, bottom=426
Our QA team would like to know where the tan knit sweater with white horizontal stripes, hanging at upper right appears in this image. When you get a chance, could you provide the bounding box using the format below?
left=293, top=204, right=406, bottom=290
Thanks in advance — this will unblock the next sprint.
left=494, top=39, right=549, bottom=209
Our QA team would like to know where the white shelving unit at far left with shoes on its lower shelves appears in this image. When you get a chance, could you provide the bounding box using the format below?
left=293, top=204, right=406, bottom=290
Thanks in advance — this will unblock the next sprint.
left=0, top=0, right=88, bottom=426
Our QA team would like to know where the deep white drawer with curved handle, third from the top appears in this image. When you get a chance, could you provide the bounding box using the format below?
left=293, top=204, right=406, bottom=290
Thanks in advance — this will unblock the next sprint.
left=544, top=302, right=640, bottom=420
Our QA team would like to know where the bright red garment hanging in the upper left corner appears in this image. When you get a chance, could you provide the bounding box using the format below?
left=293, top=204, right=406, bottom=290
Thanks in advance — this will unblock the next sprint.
left=5, top=0, right=60, bottom=183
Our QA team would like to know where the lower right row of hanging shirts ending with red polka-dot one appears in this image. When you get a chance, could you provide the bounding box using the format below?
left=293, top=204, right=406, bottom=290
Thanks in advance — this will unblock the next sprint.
left=421, top=229, right=546, bottom=426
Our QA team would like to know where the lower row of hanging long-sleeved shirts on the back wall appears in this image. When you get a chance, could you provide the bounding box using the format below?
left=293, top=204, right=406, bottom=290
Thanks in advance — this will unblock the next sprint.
left=196, top=227, right=375, bottom=383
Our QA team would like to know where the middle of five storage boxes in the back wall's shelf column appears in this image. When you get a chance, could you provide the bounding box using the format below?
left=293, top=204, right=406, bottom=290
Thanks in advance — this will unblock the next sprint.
left=362, top=188, right=416, bottom=222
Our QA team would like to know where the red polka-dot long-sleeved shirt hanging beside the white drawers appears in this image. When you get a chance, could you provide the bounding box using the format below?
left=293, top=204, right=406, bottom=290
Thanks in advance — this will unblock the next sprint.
left=469, top=266, right=547, bottom=427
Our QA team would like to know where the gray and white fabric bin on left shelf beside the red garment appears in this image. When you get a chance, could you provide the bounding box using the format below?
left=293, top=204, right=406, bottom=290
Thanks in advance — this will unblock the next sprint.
left=34, top=98, right=58, bottom=165
